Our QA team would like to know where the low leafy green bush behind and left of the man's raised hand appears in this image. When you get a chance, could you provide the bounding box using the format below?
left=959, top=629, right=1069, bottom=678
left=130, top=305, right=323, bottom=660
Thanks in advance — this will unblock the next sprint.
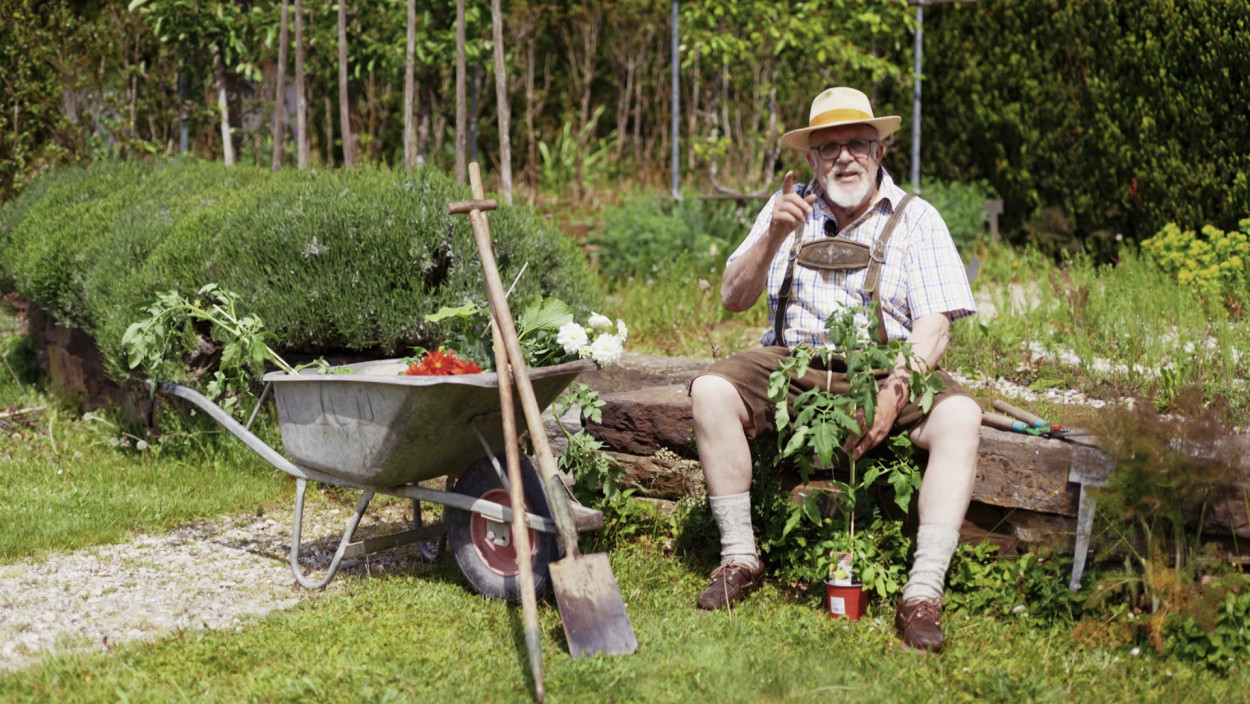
left=590, top=198, right=744, bottom=278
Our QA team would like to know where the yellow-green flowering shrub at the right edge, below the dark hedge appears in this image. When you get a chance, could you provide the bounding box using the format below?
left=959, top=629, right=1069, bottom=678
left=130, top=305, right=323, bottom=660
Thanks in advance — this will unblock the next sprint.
left=1141, top=218, right=1250, bottom=308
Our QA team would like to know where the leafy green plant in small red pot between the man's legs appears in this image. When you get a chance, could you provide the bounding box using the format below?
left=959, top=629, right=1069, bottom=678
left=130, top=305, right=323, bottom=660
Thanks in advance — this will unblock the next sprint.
left=769, top=308, right=941, bottom=620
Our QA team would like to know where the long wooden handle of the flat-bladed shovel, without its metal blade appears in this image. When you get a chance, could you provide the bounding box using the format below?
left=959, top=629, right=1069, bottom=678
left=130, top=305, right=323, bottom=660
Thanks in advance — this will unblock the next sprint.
left=469, top=161, right=579, bottom=556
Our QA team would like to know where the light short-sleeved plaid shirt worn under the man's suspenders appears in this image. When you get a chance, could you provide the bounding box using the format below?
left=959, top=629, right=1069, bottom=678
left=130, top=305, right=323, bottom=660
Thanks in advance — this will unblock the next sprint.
left=729, top=169, right=976, bottom=346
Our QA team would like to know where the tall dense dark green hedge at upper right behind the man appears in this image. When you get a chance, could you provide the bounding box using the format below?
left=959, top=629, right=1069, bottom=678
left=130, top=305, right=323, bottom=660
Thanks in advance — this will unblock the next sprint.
left=889, top=0, right=1250, bottom=247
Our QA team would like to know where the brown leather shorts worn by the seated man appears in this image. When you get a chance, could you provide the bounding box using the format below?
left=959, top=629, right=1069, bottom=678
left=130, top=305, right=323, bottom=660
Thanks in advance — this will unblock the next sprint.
left=686, top=346, right=969, bottom=438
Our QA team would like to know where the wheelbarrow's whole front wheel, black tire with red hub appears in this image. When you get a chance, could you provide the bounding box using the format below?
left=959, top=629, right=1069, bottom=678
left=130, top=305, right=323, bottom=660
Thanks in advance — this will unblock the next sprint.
left=446, top=455, right=560, bottom=604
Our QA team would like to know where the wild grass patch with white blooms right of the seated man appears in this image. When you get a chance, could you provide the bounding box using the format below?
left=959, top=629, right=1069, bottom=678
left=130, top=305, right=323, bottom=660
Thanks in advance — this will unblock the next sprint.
left=945, top=246, right=1250, bottom=425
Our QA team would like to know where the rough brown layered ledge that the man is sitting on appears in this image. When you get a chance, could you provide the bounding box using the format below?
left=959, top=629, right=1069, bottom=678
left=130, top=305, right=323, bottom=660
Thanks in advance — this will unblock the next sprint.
left=581, top=355, right=1250, bottom=591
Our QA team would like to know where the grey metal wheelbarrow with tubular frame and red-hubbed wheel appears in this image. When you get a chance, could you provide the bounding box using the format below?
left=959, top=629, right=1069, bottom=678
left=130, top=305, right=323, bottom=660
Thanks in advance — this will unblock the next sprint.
left=150, top=359, right=604, bottom=604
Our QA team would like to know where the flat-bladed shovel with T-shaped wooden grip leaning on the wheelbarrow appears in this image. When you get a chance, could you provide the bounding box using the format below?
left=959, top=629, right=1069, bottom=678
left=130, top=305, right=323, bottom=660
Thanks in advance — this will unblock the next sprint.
left=448, top=163, right=638, bottom=658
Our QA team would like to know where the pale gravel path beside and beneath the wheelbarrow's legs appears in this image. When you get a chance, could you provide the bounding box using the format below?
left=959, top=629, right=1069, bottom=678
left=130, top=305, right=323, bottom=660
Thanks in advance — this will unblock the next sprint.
left=0, top=493, right=420, bottom=671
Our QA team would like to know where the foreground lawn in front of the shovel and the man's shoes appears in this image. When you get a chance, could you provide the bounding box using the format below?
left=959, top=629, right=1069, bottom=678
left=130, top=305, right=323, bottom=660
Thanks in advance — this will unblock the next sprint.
left=0, top=544, right=1250, bottom=701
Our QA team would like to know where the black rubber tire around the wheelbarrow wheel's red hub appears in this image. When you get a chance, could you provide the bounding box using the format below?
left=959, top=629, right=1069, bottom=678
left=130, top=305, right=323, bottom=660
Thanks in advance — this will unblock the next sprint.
left=445, top=455, right=560, bottom=604
